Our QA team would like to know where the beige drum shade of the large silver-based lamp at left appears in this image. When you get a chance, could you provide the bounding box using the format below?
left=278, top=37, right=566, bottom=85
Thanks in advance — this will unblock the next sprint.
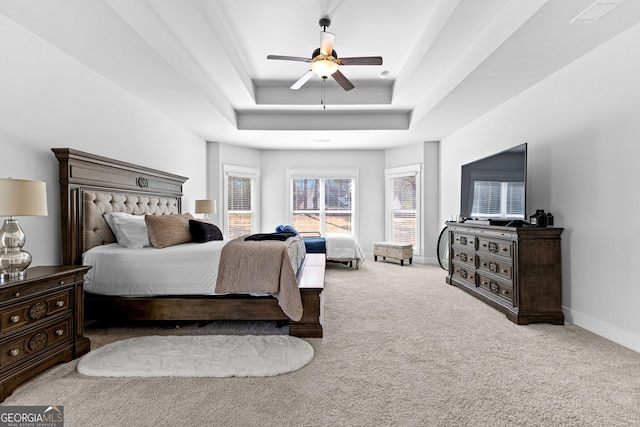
left=0, top=178, right=47, bottom=216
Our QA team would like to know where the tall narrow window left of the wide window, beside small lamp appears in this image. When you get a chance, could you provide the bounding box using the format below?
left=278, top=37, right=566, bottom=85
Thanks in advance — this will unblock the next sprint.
left=223, top=165, right=259, bottom=238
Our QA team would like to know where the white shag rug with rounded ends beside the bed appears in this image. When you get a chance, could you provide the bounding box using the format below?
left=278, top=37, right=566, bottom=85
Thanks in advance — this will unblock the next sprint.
left=77, top=335, right=313, bottom=377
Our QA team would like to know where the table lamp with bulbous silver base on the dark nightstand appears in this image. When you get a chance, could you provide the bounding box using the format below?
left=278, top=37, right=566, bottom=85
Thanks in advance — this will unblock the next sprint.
left=0, top=178, right=47, bottom=282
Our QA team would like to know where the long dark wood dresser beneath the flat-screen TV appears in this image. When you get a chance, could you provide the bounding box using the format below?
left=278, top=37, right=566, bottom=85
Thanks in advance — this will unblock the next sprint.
left=447, top=222, right=564, bottom=325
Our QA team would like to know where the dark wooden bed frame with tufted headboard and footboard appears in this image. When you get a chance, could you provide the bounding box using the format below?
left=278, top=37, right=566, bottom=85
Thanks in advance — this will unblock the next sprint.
left=52, top=148, right=325, bottom=338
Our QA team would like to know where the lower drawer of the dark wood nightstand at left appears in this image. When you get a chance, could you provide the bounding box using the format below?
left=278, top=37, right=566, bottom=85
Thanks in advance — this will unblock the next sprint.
left=0, top=315, right=73, bottom=370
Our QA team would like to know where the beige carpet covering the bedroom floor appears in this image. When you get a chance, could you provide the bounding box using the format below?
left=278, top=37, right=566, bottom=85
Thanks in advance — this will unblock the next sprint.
left=4, top=260, right=640, bottom=427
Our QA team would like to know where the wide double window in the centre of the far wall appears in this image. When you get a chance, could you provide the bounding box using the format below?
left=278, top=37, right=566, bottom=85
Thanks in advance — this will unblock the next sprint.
left=289, top=171, right=357, bottom=236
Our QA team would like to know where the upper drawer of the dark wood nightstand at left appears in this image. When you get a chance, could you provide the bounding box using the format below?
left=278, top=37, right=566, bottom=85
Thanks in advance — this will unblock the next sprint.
left=0, top=289, right=73, bottom=336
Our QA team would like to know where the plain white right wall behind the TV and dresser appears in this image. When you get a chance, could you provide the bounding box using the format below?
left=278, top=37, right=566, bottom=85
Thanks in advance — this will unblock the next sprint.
left=440, top=21, right=640, bottom=351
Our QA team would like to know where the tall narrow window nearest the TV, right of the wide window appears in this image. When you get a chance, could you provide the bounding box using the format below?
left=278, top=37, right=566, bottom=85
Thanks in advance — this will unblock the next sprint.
left=385, top=165, right=420, bottom=254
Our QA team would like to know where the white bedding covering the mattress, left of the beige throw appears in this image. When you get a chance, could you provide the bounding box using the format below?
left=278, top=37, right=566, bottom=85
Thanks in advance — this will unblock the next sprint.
left=82, top=240, right=228, bottom=296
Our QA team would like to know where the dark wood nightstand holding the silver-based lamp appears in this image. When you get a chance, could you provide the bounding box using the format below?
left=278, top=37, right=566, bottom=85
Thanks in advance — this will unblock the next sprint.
left=0, top=266, right=91, bottom=401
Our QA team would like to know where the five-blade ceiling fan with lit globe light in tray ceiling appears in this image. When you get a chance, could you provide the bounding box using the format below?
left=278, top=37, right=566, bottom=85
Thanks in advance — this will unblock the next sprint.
left=267, top=18, right=382, bottom=90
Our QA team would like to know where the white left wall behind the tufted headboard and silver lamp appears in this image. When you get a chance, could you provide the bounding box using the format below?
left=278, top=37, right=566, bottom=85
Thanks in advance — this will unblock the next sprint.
left=0, top=15, right=206, bottom=266
